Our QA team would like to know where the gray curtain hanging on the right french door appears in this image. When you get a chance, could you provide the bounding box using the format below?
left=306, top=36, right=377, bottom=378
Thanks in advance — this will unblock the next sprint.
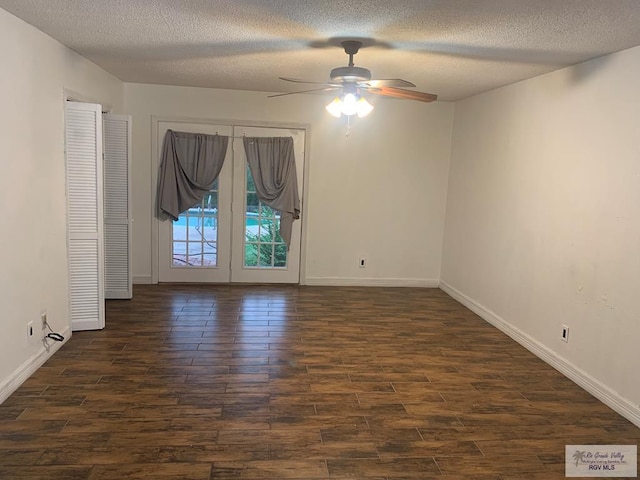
left=244, top=137, right=300, bottom=248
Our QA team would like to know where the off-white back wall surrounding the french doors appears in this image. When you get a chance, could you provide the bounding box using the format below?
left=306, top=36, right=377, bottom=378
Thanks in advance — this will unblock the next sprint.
left=125, top=84, right=453, bottom=286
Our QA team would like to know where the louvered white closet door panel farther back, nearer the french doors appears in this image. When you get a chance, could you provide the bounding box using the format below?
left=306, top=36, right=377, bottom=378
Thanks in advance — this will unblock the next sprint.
left=102, top=114, right=132, bottom=298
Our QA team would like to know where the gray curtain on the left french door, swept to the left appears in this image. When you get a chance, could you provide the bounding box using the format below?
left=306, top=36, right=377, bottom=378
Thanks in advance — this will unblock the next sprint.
left=158, top=130, right=229, bottom=220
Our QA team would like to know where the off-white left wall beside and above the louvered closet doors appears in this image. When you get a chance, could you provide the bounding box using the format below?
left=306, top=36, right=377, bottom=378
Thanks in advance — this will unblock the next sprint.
left=0, top=9, right=124, bottom=402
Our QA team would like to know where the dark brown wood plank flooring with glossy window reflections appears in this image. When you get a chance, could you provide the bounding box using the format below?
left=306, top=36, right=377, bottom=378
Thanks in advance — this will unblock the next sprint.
left=0, top=285, right=640, bottom=480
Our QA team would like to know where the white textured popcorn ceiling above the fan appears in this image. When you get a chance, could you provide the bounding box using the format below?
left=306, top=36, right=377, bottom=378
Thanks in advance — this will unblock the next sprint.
left=0, top=0, right=640, bottom=100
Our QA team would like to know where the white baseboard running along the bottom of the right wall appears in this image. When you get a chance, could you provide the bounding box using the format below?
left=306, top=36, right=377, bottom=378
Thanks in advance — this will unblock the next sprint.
left=440, top=281, right=640, bottom=427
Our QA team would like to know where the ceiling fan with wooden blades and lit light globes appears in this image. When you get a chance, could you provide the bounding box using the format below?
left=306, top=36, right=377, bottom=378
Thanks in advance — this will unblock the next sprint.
left=269, top=40, right=438, bottom=117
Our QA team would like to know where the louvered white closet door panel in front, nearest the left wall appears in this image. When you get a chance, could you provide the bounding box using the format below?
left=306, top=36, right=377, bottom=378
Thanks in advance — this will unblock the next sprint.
left=65, top=102, right=104, bottom=330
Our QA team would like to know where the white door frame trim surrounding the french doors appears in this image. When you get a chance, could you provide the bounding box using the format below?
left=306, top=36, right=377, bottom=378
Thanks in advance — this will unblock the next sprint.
left=150, top=115, right=311, bottom=285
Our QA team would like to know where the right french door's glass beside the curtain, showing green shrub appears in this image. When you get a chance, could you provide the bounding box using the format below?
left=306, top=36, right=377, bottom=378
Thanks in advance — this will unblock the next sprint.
left=244, top=165, right=287, bottom=268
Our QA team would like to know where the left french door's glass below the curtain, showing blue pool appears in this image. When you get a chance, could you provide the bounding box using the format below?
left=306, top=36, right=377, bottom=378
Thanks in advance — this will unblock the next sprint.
left=172, top=183, right=218, bottom=268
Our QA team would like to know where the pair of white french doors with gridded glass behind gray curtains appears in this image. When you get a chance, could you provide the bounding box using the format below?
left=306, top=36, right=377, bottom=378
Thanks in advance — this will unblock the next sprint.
left=157, top=121, right=305, bottom=283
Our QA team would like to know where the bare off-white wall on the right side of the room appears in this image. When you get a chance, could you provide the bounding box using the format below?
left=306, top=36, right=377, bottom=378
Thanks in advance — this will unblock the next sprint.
left=442, top=48, right=640, bottom=424
